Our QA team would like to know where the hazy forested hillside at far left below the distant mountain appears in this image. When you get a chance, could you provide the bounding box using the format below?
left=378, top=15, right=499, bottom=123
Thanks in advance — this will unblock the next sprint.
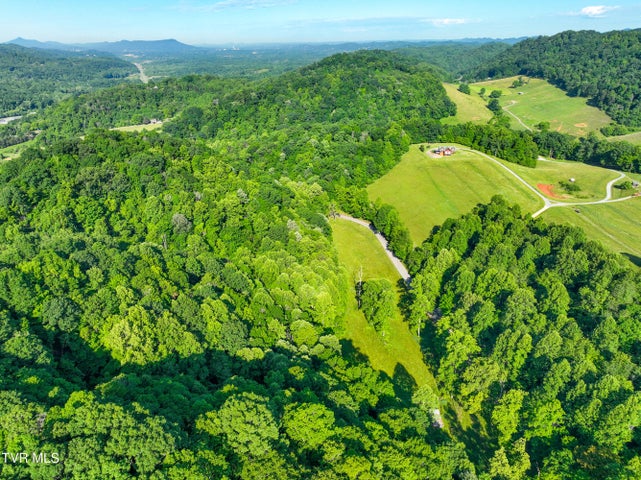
left=0, top=45, right=136, bottom=117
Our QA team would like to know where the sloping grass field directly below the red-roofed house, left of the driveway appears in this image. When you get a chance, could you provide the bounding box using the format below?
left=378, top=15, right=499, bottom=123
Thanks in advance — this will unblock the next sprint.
left=367, top=145, right=543, bottom=245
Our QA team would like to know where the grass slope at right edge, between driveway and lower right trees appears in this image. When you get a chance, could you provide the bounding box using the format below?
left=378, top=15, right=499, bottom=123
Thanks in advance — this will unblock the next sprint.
left=540, top=198, right=641, bottom=266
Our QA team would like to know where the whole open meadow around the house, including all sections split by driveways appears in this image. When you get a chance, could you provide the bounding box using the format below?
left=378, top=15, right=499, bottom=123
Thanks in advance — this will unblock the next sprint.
left=368, top=145, right=641, bottom=264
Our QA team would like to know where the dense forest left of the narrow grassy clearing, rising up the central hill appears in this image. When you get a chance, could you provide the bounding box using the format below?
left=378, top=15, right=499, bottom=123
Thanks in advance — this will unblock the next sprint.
left=0, top=50, right=484, bottom=479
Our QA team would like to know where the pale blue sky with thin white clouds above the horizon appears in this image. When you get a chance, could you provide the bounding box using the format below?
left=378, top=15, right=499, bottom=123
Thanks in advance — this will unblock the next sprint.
left=0, top=0, right=641, bottom=45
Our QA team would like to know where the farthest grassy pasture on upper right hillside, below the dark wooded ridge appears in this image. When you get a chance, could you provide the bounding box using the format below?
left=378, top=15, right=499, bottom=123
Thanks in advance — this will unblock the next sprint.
left=470, top=77, right=611, bottom=135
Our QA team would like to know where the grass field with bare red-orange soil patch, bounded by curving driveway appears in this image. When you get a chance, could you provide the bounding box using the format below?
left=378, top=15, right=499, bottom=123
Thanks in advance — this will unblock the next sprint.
left=506, top=161, right=619, bottom=202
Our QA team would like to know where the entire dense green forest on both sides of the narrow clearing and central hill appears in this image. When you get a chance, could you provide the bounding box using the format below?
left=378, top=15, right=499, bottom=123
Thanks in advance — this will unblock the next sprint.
left=0, top=46, right=641, bottom=480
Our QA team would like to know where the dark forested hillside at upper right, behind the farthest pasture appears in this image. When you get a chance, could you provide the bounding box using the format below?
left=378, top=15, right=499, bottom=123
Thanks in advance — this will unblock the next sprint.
left=468, top=29, right=641, bottom=127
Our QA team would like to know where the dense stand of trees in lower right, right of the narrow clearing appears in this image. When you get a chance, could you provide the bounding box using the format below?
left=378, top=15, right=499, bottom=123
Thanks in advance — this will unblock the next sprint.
left=410, top=197, right=641, bottom=479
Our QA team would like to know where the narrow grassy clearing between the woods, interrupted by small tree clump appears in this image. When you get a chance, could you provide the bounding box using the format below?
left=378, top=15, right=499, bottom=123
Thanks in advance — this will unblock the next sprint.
left=331, top=219, right=436, bottom=388
